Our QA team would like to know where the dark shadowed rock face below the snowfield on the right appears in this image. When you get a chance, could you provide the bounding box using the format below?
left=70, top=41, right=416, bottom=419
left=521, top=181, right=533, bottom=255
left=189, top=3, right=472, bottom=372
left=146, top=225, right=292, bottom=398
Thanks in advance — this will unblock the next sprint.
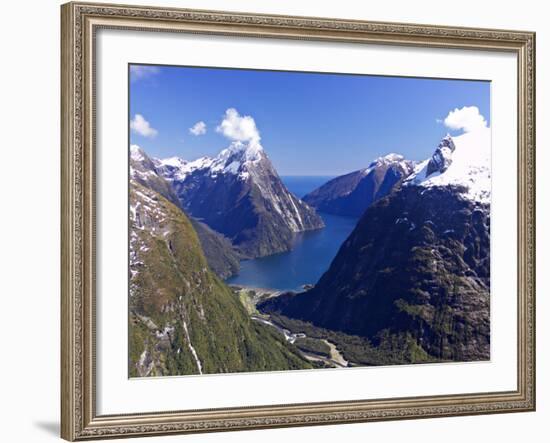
left=261, top=186, right=490, bottom=361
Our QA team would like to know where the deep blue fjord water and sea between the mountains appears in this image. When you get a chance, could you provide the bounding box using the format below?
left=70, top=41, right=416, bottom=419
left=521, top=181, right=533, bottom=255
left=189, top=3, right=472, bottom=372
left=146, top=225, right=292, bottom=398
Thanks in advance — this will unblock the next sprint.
left=226, top=177, right=357, bottom=290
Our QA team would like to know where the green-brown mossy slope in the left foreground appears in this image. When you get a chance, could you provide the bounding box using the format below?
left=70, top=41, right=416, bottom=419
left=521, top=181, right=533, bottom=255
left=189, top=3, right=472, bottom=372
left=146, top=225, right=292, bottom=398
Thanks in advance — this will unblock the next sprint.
left=129, top=180, right=311, bottom=377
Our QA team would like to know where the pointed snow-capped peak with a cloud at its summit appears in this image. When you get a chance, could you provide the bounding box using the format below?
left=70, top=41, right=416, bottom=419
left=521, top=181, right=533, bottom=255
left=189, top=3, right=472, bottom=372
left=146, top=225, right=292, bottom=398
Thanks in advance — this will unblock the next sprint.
left=156, top=141, right=323, bottom=257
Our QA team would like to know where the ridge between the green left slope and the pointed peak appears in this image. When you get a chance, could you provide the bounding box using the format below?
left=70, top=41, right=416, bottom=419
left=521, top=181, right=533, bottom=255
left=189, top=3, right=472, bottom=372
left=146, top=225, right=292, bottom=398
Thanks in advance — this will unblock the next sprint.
left=130, top=145, right=240, bottom=278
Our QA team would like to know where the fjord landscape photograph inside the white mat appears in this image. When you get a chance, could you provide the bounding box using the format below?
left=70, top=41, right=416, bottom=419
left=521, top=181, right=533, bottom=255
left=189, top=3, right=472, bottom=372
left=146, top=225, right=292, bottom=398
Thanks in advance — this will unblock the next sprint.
left=127, top=63, right=492, bottom=378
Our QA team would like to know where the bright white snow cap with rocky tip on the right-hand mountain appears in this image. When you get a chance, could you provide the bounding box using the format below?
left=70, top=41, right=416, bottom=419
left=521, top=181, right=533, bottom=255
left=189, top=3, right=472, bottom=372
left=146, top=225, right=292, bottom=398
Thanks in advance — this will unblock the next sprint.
left=404, top=128, right=491, bottom=203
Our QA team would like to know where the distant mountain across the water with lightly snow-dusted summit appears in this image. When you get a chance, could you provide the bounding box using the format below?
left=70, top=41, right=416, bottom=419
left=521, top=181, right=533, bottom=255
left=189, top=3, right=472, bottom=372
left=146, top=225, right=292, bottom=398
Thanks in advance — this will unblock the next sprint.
left=303, top=154, right=414, bottom=217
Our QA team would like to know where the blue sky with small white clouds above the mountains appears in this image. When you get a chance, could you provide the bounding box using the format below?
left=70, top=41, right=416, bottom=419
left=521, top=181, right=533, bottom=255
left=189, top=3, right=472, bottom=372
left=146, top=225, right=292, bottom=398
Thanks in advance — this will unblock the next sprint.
left=129, top=65, right=490, bottom=176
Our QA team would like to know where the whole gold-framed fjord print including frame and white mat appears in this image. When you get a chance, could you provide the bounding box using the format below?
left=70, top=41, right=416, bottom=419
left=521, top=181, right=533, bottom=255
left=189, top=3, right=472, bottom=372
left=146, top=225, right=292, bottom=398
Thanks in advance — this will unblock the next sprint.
left=61, top=2, right=535, bottom=440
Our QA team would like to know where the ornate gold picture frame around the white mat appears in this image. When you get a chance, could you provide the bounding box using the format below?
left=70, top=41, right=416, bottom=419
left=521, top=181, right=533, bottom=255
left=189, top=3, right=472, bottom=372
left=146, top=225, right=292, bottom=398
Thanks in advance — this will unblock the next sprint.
left=61, top=3, right=535, bottom=441
